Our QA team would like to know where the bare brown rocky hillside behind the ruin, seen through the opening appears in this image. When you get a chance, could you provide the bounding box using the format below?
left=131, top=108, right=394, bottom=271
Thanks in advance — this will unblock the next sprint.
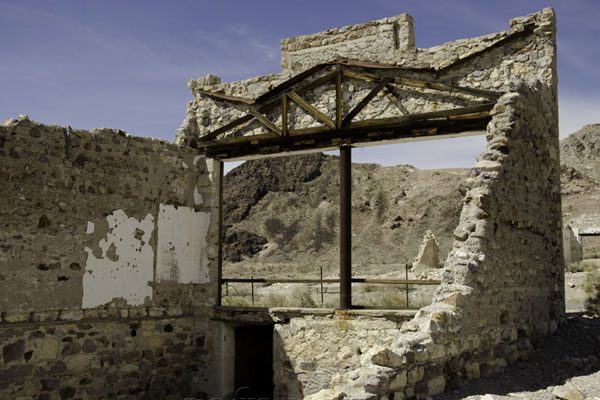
left=224, top=125, right=600, bottom=277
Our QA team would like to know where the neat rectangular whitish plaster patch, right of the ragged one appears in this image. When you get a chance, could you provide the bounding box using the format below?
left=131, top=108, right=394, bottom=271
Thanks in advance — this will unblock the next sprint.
left=156, top=204, right=210, bottom=283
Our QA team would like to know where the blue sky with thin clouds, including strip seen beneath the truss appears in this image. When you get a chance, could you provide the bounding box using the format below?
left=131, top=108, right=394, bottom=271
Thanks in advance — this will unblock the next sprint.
left=0, top=0, right=600, bottom=168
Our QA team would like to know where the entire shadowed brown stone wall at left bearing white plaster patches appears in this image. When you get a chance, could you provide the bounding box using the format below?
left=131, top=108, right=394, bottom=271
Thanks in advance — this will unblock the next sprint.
left=0, top=116, right=220, bottom=399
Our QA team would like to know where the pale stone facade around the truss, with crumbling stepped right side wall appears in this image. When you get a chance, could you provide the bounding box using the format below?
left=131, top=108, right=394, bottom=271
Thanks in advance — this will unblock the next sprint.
left=178, top=9, right=564, bottom=399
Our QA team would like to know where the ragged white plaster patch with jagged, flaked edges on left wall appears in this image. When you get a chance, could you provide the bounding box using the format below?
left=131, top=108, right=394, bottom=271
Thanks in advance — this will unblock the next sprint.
left=82, top=210, right=154, bottom=308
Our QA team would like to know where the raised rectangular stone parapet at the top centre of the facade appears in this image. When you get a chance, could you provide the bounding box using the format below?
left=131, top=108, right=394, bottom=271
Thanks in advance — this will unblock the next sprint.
left=281, top=14, right=415, bottom=73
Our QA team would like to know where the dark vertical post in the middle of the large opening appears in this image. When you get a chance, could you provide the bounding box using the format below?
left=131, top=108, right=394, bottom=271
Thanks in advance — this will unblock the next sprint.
left=340, top=146, right=352, bottom=309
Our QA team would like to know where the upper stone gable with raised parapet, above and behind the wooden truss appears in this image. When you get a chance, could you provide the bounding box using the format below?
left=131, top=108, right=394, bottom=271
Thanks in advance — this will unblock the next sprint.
left=176, top=8, right=557, bottom=148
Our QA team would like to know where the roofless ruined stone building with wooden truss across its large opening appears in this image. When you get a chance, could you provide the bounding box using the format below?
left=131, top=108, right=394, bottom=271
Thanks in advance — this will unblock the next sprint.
left=0, top=9, right=564, bottom=399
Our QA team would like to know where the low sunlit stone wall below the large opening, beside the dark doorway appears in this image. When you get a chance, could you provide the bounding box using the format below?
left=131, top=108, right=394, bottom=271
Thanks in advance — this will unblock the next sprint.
left=273, top=310, right=414, bottom=399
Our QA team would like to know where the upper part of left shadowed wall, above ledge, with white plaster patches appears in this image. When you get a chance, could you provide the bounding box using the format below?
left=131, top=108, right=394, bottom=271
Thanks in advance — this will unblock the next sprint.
left=0, top=117, right=220, bottom=312
